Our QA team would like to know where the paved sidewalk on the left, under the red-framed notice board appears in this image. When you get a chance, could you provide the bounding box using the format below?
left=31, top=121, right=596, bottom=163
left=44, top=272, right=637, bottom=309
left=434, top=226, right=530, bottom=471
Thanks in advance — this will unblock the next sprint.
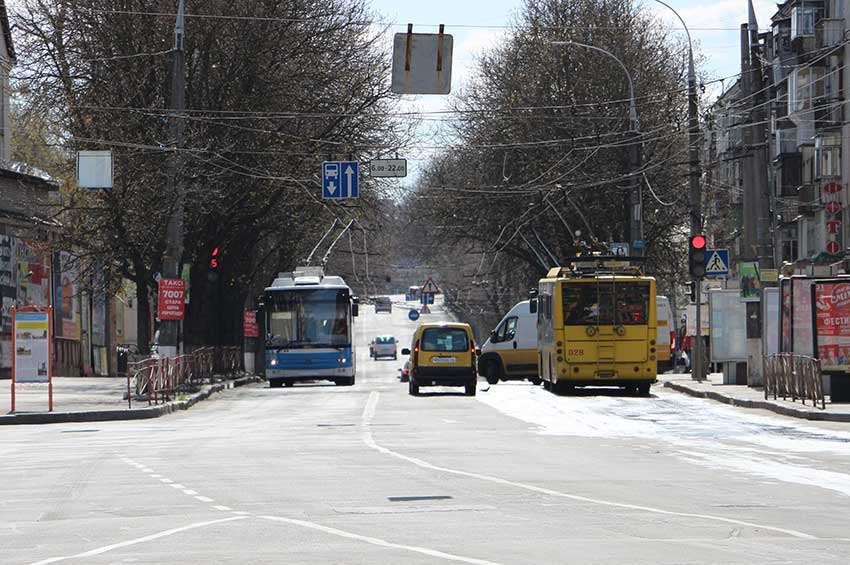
left=0, top=376, right=261, bottom=425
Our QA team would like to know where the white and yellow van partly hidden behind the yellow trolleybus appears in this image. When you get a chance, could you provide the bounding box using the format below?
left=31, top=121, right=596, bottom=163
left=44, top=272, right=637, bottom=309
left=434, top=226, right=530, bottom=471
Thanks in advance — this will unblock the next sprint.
left=478, top=300, right=540, bottom=384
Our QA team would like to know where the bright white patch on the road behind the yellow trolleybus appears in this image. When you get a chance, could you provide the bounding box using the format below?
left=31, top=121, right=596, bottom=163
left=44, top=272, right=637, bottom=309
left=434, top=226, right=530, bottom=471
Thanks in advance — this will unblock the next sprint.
left=478, top=384, right=850, bottom=496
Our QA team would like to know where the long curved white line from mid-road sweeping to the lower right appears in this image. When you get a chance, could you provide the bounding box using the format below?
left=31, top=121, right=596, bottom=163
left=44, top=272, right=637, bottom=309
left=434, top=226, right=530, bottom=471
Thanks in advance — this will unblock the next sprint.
left=362, top=391, right=818, bottom=539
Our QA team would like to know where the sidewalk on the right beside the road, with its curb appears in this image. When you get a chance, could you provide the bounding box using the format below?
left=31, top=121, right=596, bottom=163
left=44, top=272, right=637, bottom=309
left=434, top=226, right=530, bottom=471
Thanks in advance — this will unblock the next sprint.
left=658, top=373, right=850, bottom=422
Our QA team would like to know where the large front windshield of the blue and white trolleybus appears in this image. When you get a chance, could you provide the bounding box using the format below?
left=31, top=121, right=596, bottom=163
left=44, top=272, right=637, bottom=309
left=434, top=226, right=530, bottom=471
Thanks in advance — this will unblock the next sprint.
left=266, top=289, right=351, bottom=348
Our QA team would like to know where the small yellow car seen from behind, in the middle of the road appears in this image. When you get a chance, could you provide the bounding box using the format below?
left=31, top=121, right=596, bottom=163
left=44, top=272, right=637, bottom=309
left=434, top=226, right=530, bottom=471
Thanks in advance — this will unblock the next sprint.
left=401, top=323, right=478, bottom=396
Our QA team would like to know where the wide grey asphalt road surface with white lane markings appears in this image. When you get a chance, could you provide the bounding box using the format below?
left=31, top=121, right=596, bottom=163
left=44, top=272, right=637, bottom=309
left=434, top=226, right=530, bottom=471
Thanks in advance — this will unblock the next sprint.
left=0, top=303, right=850, bottom=564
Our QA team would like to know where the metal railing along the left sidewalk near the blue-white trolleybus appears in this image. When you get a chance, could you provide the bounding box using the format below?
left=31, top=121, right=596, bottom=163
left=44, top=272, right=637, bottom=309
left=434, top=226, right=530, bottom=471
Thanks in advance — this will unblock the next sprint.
left=127, top=347, right=242, bottom=408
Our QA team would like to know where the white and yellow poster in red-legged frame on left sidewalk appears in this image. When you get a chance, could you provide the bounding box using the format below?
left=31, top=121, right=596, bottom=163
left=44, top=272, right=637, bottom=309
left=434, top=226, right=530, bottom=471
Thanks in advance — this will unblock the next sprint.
left=13, top=312, right=50, bottom=383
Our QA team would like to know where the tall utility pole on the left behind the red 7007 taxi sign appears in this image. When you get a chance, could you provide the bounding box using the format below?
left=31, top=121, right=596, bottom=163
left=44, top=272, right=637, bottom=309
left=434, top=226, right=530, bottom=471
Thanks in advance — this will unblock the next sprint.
left=159, top=0, right=186, bottom=357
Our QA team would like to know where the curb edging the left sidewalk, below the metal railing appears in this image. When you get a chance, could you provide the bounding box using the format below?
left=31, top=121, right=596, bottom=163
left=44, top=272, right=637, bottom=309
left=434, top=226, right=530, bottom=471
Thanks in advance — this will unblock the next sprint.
left=0, top=376, right=263, bottom=426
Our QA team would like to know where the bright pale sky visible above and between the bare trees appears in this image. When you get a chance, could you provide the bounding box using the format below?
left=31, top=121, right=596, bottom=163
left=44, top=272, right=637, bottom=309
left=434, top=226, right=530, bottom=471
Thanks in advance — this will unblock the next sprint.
left=371, top=0, right=776, bottom=186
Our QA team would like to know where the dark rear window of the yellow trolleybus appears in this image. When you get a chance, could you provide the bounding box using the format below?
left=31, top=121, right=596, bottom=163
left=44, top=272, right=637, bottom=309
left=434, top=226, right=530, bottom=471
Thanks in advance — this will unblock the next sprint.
left=561, top=281, right=649, bottom=326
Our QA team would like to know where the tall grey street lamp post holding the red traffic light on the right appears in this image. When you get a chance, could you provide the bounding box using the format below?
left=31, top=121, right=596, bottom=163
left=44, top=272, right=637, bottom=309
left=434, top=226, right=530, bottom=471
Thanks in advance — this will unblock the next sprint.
left=655, top=0, right=705, bottom=380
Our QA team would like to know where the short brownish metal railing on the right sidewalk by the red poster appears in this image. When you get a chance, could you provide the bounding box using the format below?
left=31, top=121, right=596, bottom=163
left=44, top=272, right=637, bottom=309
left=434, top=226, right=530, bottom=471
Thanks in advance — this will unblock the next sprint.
left=764, top=353, right=826, bottom=410
